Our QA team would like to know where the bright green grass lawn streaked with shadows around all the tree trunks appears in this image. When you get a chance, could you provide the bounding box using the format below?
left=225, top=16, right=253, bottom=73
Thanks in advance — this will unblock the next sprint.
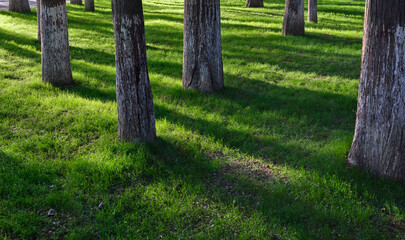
left=0, top=0, right=405, bottom=239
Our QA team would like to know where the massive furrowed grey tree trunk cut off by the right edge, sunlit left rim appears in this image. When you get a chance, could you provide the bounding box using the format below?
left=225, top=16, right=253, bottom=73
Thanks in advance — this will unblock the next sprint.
left=348, top=0, right=405, bottom=183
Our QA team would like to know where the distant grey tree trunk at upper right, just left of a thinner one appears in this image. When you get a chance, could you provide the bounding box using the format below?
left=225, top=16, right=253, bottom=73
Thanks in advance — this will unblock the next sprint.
left=282, top=0, right=305, bottom=35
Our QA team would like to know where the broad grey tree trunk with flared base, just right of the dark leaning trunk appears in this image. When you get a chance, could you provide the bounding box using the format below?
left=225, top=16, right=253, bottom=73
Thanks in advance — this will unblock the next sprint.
left=183, top=0, right=224, bottom=92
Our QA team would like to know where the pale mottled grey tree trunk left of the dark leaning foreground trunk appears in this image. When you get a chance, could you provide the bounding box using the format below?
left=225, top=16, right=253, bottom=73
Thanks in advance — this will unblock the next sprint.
left=40, top=0, right=73, bottom=85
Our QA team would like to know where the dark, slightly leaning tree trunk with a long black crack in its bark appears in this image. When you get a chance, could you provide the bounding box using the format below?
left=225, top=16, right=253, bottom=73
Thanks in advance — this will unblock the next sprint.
left=111, top=0, right=156, bottom=141
